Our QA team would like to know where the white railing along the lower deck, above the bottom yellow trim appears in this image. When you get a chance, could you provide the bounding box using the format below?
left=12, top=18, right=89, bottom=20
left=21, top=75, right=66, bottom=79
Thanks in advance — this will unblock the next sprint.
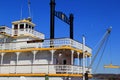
left=0, top=64, right=91, bottom=74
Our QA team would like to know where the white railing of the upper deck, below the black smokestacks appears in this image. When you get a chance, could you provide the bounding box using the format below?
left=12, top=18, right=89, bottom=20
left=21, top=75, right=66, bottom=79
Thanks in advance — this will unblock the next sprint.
left=0, top=38, right=92, bottom=53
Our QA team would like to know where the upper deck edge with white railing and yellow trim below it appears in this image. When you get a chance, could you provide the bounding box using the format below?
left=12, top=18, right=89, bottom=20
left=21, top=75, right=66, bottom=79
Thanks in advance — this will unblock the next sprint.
left=0, top=38, right=92, bottom=54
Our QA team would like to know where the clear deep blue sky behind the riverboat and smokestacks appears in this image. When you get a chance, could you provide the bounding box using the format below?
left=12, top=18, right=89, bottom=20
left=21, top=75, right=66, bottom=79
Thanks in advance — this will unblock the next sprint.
left=0, top=0, right=120, bottom=73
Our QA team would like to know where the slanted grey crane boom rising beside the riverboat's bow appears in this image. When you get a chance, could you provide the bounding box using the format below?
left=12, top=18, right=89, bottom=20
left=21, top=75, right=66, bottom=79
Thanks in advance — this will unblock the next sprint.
left=85, top=27, right=112, bottom=80
